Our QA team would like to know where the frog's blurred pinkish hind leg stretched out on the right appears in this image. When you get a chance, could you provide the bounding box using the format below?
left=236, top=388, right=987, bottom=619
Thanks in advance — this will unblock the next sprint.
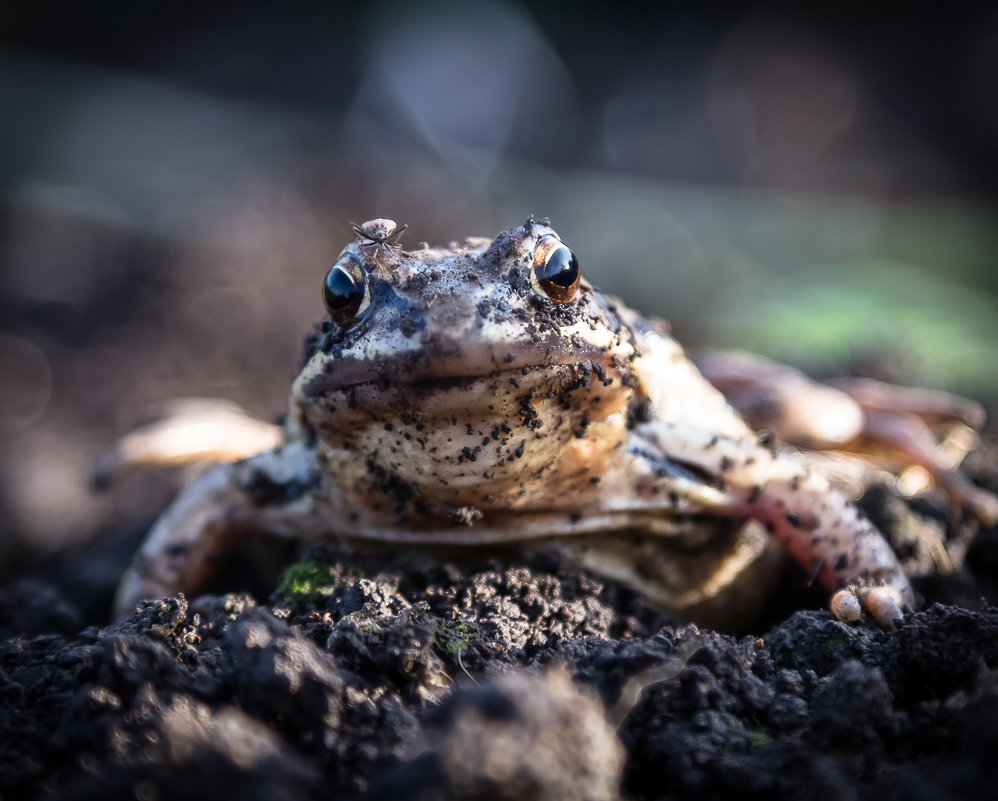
left=697, top=351, right=998, bottom=525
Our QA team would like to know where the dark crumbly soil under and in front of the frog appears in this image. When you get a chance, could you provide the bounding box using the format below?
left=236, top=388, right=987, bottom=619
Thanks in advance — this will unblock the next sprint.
left=0, top=446, right=998, bottom=801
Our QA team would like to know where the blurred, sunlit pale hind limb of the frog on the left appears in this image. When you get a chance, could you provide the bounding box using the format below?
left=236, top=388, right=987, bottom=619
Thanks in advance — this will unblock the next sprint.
left=91, top=398, right=282, bottom=489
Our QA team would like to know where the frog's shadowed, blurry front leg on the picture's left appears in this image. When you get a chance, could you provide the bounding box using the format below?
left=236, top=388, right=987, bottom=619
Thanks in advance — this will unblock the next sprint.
left=114, top=442, right=319, bottom=618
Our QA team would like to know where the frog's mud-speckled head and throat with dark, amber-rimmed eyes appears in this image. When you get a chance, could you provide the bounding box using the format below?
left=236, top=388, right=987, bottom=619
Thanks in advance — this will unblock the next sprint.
left=291, top=219, right=642, bottom=509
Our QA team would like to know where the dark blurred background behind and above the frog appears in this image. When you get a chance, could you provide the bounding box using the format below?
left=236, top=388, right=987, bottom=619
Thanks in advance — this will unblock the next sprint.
left=0, top=0, right=998, bottom=580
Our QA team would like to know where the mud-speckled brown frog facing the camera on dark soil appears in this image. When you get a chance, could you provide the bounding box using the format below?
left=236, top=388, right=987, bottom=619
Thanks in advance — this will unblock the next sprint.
left=106, top=217, right=996, bottom=629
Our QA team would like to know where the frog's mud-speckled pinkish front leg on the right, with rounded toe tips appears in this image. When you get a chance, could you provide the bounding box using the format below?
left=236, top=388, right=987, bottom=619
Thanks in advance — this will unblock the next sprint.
left=641, top=424, right=915, bottom=629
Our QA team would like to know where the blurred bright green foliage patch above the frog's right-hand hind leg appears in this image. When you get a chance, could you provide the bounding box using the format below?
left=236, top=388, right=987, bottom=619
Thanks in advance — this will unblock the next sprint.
left=719, top=258, right=998, bottom=399
